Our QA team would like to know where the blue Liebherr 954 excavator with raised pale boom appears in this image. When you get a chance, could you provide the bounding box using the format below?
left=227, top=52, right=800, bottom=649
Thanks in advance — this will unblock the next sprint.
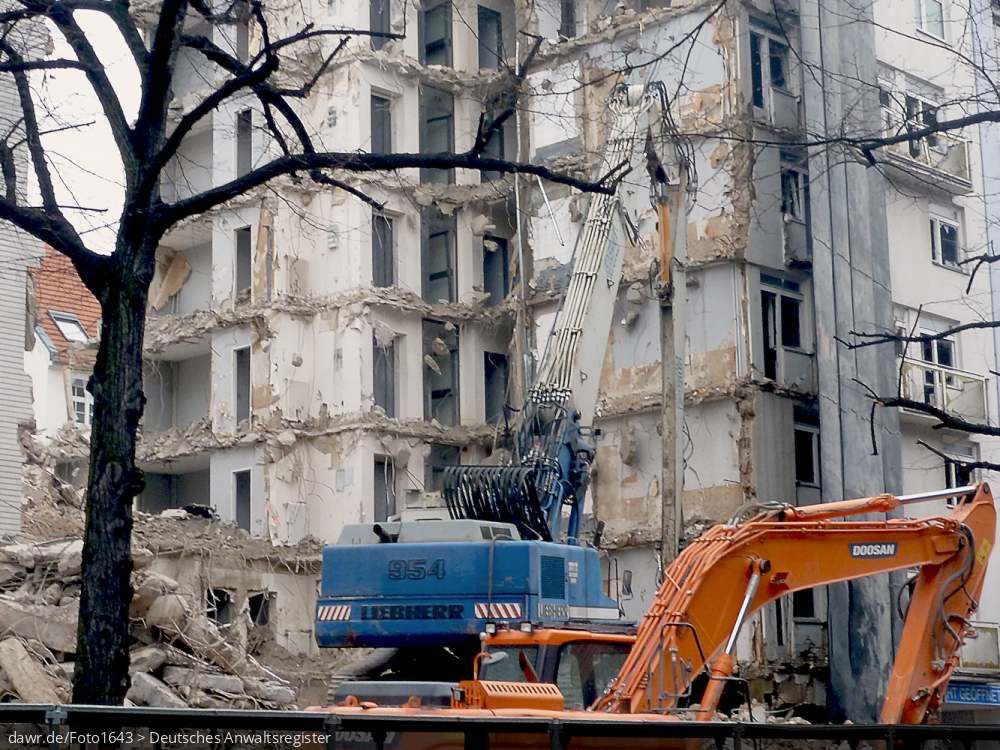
left=316, top=85, right=666, bottom=678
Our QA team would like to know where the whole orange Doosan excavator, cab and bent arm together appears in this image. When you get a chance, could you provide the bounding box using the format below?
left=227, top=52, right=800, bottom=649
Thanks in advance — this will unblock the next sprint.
left=323, top=483, right=996, bottom=750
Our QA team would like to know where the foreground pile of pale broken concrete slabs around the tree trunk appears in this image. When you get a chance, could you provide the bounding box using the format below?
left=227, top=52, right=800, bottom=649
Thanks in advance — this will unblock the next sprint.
left=0, top=537, right=312, bottom=708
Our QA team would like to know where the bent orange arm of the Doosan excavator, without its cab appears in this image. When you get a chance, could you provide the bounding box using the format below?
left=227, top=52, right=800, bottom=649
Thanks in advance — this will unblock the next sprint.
left=596, top=483, right=996, bottom=724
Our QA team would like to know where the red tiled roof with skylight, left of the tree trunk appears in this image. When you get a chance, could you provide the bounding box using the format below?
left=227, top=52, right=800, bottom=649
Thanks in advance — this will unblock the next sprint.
left=28, top=245, right=101, bottom=352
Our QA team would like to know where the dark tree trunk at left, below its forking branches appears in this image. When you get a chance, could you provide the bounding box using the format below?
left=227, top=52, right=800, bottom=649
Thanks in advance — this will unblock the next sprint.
left=73, top=262, right=148, bottom=706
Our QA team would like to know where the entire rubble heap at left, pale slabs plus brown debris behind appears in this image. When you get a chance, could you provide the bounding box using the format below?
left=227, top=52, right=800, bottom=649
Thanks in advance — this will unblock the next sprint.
left=8, top=464, right=348, bottom=709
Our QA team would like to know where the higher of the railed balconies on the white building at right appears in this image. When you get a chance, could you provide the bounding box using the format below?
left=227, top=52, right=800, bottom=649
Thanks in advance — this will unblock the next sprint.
left=882, top=109, right=972, bottom=195
